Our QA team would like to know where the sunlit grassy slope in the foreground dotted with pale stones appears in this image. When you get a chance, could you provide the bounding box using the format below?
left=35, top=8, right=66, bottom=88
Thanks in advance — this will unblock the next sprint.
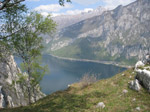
left=0, top=69, right=150, bottom=112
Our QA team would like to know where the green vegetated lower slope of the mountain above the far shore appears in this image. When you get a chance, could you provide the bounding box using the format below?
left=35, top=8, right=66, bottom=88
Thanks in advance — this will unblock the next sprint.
left=44, top=37, right=137, bottom=65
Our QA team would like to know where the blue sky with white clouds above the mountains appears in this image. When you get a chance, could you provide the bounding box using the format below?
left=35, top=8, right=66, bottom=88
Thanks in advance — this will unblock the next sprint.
left=24, top=0, right=135, bottom=16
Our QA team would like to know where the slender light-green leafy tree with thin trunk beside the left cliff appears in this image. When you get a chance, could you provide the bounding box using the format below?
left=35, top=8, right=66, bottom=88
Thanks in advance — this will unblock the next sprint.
left=10, top=12, right=56, bottom=104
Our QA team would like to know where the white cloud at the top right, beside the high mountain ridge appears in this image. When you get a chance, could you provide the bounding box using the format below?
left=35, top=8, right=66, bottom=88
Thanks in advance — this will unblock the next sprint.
left=102, top=0, right=135, bottom=9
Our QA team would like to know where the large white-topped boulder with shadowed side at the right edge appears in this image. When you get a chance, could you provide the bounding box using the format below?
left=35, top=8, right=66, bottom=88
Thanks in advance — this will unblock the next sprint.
left=136, top=69, right=150, bottom=92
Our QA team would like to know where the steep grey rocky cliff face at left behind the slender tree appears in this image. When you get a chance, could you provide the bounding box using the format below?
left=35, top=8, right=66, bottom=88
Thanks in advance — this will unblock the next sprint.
left=0, top=56, right=44, bottom=108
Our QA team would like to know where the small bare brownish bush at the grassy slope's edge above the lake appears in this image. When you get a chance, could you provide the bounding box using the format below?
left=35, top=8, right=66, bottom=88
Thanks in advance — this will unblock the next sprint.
left=80, top=73, right=97, bottom=88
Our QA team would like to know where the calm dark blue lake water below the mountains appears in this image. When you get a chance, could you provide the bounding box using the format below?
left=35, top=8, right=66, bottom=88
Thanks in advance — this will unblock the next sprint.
left=15, top=55, right=126, bottom=94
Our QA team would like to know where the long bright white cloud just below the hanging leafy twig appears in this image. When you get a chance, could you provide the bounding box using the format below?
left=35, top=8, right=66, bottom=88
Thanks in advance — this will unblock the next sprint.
left=34, top=4, right=72, bottom=12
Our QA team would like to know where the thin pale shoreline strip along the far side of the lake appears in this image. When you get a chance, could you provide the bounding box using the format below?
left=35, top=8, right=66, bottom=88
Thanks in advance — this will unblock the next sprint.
left=46, top=54, right=132, bottom=68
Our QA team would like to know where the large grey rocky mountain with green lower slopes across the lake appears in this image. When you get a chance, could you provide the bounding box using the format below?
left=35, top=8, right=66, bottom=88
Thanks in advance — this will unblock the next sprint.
left=45, top=0, right=150, bottom=65
